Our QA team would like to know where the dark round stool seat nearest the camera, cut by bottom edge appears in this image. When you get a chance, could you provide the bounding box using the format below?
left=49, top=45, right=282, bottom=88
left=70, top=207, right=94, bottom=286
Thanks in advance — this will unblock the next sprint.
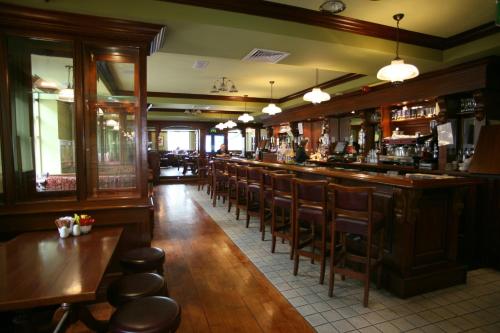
left=109, top=296, right=181, bottom=333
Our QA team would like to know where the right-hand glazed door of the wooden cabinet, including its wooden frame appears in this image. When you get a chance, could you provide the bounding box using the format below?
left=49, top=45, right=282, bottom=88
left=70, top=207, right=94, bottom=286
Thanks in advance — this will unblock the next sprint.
left=87, top=49, right=140, bottom=196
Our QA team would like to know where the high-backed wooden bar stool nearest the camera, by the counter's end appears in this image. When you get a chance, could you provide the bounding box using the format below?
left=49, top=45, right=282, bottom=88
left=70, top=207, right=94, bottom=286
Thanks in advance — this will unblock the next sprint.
left=328, top=184, right=384, bottom=307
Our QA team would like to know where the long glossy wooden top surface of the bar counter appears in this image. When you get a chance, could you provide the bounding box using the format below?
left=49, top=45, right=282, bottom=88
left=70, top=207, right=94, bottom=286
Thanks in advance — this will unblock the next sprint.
left=225, top=157, right=479, bottom=189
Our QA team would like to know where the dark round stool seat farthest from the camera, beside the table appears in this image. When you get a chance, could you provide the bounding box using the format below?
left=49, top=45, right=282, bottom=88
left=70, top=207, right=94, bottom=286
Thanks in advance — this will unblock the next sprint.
left=120, top=247, right=165, bottom=274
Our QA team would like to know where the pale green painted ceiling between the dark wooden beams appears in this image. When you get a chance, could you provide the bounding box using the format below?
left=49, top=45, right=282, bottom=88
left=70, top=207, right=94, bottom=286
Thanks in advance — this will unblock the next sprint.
left=0, top=0, right=500, bottom=121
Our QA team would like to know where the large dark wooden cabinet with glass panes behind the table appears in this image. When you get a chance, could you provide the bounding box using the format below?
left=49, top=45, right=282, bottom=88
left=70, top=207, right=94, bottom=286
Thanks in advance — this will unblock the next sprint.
left=0, top=4, right=164, bottom=254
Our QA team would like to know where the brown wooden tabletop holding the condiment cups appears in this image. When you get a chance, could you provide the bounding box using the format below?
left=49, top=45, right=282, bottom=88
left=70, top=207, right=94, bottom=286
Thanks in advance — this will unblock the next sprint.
left=0, top=227, right=123, bottom=311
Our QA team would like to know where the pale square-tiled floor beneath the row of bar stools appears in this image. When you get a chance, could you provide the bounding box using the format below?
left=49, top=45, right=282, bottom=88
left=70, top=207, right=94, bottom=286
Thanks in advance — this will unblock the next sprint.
left=186, top=186, right=500, bottom=333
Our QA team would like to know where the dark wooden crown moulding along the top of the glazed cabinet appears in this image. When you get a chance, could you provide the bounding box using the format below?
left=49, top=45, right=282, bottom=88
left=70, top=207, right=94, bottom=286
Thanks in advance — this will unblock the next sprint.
left=0, top=4, right=166, bottom=55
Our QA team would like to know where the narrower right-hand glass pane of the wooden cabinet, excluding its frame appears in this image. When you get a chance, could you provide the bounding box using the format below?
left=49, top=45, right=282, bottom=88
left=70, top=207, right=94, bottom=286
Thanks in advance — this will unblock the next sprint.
left=95, top=60, right=138, bottom=190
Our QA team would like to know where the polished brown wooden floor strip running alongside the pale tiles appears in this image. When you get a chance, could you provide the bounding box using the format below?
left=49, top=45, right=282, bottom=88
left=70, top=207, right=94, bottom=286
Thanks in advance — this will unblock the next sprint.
left=72, top=185, right=314, bottom=333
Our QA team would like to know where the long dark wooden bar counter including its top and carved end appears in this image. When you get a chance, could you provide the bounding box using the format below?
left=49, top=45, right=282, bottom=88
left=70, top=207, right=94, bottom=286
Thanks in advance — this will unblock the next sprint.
left=221, top=158, right=478, bottom=297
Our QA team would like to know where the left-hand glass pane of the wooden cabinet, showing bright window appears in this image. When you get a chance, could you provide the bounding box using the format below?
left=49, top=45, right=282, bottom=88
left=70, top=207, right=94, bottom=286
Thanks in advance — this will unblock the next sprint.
left=8, top=37, right=76, bottom=199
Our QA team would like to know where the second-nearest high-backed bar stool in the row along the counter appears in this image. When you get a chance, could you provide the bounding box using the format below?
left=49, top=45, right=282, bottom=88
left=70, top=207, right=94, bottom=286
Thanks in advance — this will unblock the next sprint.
left=293, top=179, right=328, bottom=284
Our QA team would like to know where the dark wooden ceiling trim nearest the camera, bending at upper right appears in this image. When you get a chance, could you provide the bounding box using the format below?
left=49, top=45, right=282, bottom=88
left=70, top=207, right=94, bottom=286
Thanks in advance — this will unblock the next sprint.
left=160, top=0, right=500, bottom=50
